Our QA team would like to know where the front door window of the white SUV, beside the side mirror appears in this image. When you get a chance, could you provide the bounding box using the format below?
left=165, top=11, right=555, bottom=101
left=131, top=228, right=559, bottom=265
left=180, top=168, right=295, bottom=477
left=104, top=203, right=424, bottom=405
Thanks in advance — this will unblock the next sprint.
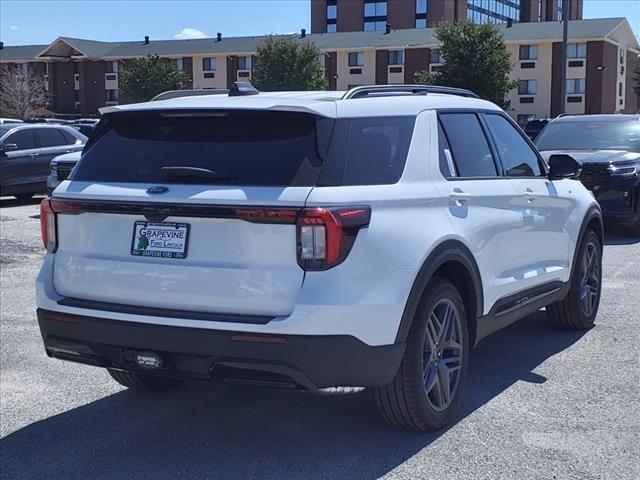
left=485, top=114, right=542, bottom=177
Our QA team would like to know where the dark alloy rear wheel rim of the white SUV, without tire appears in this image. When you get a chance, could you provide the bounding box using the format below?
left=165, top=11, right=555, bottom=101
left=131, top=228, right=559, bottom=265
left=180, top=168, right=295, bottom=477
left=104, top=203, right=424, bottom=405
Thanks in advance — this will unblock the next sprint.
left=422, top=298, right=464, bottom=412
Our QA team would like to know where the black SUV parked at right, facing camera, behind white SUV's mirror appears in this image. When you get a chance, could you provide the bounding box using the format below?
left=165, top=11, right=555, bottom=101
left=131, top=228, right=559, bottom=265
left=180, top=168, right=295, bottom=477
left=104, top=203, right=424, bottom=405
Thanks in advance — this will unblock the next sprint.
left=536, top=115, right=640, bottom=236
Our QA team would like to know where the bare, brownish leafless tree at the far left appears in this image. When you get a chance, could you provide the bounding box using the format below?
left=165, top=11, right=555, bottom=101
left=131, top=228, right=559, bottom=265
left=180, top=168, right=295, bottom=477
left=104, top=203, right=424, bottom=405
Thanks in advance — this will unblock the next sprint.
left=0, top=65, right=49, bottom=119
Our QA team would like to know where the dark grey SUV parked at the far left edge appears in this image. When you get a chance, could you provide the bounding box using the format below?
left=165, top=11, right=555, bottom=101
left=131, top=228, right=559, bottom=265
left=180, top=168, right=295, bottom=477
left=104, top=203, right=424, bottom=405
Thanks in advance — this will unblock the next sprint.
left=0, top=123, right=87, bottom=199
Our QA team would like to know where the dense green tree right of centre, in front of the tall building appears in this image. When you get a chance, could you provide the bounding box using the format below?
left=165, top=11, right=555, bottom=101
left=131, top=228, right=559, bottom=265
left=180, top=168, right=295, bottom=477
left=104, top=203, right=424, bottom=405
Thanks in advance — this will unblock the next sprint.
left=416, top=22, right=518, bottom=108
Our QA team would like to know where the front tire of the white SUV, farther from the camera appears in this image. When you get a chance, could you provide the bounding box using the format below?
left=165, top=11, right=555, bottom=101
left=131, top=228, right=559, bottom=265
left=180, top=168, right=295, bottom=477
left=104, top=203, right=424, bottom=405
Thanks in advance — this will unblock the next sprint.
left=547, top=230, right=602, bottom=330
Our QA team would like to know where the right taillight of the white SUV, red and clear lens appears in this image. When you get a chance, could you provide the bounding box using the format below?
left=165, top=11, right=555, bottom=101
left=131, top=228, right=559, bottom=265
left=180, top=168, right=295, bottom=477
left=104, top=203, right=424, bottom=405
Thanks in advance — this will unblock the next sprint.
left=297, top=207, right=371, bottom=270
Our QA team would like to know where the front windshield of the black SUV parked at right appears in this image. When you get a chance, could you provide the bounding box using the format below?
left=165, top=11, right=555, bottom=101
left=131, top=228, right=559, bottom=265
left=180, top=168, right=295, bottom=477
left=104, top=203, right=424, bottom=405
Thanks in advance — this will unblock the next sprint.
left=536, top=121, right=640, bottom=152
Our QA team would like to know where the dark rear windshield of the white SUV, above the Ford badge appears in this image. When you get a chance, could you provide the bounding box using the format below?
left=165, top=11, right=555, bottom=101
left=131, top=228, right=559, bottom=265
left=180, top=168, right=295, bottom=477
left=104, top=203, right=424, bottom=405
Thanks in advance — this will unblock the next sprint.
left=72, top=111, right=330, bottom=186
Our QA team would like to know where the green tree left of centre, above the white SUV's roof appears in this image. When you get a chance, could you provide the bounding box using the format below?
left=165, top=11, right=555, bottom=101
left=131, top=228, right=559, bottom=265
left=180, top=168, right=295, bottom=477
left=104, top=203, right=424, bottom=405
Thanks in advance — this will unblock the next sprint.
left=120, top=55, right=189, bottom=102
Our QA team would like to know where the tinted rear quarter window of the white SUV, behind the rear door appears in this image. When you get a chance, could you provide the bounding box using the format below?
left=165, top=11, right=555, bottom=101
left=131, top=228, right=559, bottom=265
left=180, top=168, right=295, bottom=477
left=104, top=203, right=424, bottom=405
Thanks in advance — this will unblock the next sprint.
left=319, top=116, right=416, bottom=186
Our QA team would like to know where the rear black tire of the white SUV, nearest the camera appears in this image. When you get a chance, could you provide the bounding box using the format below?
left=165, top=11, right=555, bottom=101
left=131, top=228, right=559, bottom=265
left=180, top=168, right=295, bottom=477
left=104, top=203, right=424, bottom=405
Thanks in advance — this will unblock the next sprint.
left=374, top=277, right=469, bottom=432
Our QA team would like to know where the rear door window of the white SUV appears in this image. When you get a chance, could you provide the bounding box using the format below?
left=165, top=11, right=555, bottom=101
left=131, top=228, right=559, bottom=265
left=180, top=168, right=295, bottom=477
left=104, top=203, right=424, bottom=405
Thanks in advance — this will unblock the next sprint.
left=440, top=113, right=498, bottom=177
